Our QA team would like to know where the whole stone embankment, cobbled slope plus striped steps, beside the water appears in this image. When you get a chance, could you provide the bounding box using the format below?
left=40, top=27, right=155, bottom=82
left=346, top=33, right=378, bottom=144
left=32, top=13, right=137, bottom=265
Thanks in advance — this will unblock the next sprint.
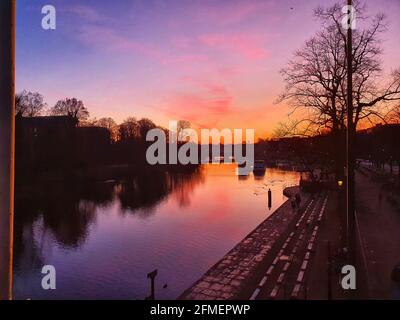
left=179, top=187, right=328, bottom=300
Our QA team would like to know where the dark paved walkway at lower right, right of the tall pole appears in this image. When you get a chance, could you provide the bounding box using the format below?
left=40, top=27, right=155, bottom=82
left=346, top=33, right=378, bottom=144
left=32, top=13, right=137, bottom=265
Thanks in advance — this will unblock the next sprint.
left=356, top=172, right=400, bottom=299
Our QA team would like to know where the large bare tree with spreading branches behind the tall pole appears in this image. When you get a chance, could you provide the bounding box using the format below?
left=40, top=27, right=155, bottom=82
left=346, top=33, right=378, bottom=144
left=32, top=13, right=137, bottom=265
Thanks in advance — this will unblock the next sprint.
left=278, top=2, right=400, bottom=135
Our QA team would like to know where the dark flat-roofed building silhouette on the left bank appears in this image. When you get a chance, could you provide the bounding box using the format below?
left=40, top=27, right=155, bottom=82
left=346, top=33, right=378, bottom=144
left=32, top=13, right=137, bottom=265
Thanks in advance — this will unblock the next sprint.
left=16, top=116, right=111, bottom=170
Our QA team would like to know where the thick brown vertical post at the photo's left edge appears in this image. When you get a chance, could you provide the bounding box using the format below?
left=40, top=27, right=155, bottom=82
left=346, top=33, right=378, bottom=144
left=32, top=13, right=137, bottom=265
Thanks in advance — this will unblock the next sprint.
left=0, top=0, right=15, bottom=300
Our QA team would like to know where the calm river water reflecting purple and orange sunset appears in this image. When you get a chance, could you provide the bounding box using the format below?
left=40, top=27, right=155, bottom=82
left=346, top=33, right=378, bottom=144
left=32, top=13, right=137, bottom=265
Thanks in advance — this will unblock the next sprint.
left=14, top=164, right=298, bottom=299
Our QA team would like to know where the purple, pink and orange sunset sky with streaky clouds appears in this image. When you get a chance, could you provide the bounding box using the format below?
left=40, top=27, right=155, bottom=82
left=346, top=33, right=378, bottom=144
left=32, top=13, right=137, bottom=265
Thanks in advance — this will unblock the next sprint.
left=17, top=0, right=400, bottom=137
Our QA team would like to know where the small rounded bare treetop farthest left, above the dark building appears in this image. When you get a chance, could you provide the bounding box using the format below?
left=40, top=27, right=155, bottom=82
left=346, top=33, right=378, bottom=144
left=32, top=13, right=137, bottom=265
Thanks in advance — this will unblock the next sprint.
left=15, top=90, right=46, bottom=117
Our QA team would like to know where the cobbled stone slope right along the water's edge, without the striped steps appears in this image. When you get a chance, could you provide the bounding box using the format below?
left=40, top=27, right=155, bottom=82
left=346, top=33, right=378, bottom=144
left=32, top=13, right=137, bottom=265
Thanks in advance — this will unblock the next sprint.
left=178, top=187, right=311, bottom=300
